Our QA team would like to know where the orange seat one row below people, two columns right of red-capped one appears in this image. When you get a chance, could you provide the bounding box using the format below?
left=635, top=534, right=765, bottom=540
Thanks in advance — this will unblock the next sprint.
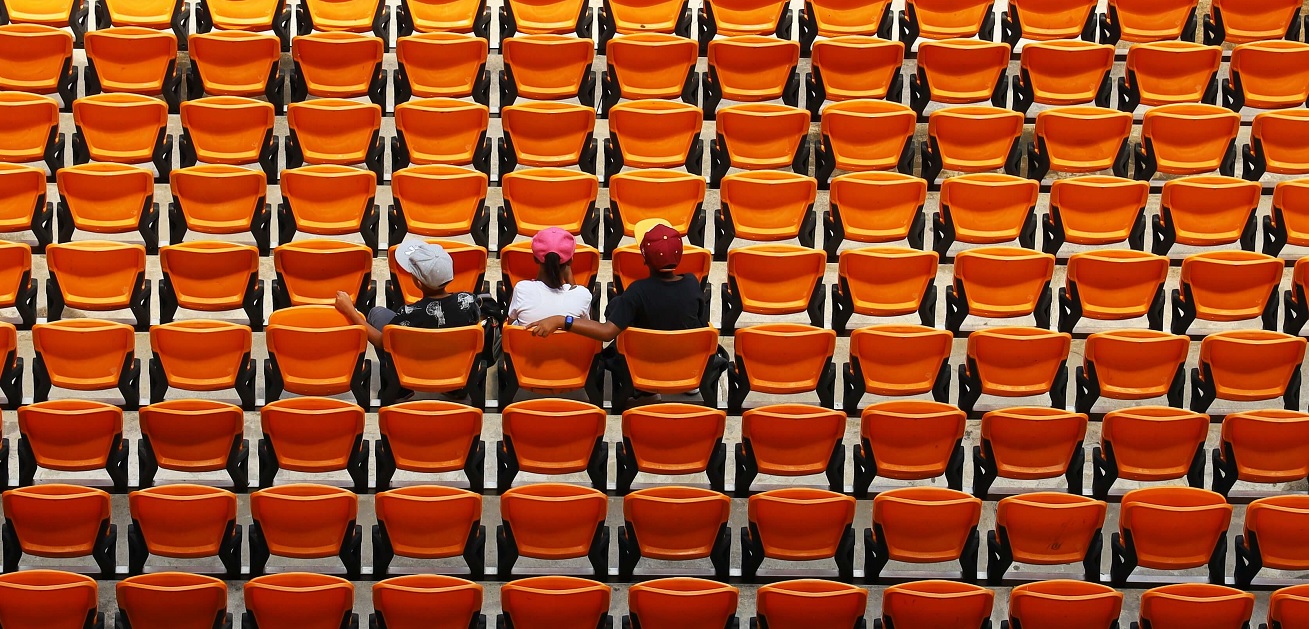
left=853, top=400, right=967, bottom=497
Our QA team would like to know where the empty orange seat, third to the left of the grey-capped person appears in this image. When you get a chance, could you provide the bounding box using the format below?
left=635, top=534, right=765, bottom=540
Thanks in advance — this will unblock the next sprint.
left=31, top=319, right=141, bottom=409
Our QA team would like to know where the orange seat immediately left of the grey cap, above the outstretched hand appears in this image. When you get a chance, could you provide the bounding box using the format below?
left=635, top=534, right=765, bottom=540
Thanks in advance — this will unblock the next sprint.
left=272, top=239, right=377, bottom=311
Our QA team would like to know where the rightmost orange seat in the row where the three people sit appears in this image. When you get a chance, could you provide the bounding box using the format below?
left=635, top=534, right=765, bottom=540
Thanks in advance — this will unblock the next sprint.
left=1191, top=330, right=1306, bottom=413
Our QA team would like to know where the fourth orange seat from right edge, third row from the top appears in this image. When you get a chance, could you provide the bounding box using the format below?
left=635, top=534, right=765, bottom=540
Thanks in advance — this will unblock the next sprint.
left=919, top=106, right=1024, bottom=182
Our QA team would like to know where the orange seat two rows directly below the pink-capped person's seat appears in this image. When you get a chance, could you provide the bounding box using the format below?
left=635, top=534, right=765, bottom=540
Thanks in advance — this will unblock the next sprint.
left=496, top=483, right=609, bottom=575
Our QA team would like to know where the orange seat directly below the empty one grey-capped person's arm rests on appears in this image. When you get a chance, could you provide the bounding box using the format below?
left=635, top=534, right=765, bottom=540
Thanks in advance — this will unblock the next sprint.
left=259, top=398, right=368, bottom=492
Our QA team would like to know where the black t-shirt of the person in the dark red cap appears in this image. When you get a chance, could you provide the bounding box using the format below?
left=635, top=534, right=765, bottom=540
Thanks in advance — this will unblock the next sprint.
left=605, top=273, right=708, bottom=330
